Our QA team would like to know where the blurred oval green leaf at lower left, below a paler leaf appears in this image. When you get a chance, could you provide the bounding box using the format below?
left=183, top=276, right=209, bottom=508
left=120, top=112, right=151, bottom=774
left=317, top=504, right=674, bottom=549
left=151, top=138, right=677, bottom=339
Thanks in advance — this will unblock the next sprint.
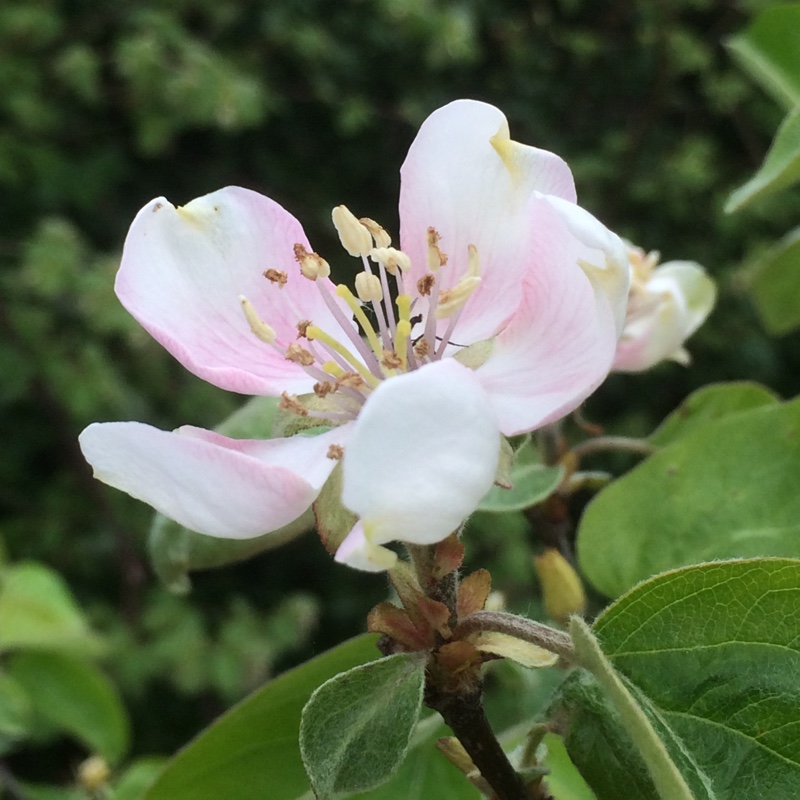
left=8, top=652, right=130, bottom=764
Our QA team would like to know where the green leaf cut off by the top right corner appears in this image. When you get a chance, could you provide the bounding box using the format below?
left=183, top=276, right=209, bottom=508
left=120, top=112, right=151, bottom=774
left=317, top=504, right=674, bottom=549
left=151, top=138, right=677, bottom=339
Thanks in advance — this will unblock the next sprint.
left=728, top=3, right=800, bottom=109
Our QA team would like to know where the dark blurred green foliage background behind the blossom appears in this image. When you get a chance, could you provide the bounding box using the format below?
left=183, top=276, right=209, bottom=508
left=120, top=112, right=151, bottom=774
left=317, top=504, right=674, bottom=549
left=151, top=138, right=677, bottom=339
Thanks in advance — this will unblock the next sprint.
left=0, top=0, right=800, bottom=784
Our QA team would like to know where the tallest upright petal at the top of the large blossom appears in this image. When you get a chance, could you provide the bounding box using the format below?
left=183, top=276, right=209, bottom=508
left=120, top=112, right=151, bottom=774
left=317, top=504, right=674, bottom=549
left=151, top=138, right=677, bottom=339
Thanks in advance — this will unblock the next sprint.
left=400, top=100, right=575, bottom=342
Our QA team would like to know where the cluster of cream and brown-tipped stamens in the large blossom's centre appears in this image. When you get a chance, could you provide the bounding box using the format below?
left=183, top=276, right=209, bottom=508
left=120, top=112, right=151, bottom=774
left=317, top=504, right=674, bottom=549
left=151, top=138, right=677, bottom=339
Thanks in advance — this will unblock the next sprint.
left=240, top=206, right=480, bottom=422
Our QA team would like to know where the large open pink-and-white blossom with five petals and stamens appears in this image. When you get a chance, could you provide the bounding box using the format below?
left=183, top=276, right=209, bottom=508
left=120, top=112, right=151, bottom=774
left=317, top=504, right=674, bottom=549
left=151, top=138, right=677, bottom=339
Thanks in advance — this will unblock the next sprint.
left=80, top=101, right=629, bottom=570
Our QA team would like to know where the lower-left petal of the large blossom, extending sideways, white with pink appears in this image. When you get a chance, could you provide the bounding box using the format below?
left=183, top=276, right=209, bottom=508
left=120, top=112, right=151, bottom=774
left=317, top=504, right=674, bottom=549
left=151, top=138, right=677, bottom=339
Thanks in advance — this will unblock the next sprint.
left=80, top=422, right=351, bottom=539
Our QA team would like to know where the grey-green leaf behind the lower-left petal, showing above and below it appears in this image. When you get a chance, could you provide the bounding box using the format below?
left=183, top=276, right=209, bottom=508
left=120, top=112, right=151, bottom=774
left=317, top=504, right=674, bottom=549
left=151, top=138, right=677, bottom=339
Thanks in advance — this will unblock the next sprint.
left=148, top=397, right=314, bottom=594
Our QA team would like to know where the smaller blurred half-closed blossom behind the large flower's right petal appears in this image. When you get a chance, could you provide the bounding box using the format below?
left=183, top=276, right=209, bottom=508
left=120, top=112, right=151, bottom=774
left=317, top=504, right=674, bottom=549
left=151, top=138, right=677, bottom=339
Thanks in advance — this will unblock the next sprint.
left=614, top=245, right=717, bottom=372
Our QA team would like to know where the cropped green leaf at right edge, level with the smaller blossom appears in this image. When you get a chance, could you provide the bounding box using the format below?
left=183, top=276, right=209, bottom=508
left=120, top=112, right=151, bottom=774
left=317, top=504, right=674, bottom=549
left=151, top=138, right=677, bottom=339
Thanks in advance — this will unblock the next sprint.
left=751, top=228, right=800, bottom=336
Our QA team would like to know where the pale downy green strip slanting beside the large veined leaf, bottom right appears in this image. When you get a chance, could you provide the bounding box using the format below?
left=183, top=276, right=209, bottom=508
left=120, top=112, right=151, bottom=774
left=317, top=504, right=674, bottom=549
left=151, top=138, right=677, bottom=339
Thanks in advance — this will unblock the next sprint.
left=569, top=617, right=694, bottom=800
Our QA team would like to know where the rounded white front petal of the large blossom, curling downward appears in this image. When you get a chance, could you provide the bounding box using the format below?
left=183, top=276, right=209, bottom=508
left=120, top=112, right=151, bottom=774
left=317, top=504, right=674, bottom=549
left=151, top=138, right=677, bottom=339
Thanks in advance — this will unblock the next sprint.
left=342, top=359, right=500, bottom=544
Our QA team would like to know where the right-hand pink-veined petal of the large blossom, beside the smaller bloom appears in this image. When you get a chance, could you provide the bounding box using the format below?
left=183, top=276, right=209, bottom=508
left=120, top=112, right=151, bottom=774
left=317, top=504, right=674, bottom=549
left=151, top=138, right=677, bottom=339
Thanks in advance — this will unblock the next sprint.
left=476, top=199, right=628, bottom=436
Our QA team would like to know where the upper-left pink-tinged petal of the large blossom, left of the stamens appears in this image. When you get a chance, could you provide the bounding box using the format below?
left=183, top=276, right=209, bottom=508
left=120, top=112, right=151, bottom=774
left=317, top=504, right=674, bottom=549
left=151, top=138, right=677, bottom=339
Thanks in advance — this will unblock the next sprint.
left=116, top=187, right=354, bottom=395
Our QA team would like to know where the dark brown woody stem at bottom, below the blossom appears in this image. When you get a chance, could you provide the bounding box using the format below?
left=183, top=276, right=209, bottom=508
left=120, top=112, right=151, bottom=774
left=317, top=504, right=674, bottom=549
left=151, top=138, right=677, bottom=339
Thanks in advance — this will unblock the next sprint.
left=425, top=686, right=530, bottom=800
